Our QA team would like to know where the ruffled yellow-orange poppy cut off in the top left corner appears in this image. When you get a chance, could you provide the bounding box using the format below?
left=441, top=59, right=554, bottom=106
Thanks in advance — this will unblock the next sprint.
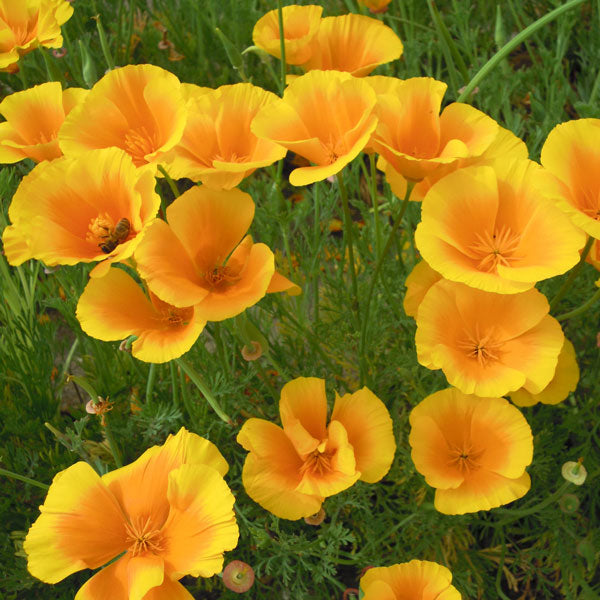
left=0, top=0, right=73, bottom=73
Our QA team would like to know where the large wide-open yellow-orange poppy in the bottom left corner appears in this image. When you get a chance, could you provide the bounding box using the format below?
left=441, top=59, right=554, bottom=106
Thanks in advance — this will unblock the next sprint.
left=23, top=428, right=238, bottom=600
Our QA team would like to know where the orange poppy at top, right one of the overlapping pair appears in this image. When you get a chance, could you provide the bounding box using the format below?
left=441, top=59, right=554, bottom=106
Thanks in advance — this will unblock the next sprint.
left=302, top=13, right=403, bottom=77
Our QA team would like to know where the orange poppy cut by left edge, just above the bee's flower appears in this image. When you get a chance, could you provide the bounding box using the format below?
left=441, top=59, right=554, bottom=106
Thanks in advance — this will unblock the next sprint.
left=0, top=81, right=87, bottom=163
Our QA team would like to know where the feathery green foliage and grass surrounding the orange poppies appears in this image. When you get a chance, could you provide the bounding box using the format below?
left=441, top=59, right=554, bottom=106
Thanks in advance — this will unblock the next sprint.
left=0, top=0, right=600, bottom=600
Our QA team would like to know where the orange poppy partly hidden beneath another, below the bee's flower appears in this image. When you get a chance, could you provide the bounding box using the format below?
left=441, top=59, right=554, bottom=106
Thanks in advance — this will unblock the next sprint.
left=77, top=268, right=206, bottom=363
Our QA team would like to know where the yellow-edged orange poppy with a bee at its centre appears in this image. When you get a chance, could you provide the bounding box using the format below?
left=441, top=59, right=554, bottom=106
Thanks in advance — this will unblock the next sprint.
left=2, top=148, right=160, bottom=275
